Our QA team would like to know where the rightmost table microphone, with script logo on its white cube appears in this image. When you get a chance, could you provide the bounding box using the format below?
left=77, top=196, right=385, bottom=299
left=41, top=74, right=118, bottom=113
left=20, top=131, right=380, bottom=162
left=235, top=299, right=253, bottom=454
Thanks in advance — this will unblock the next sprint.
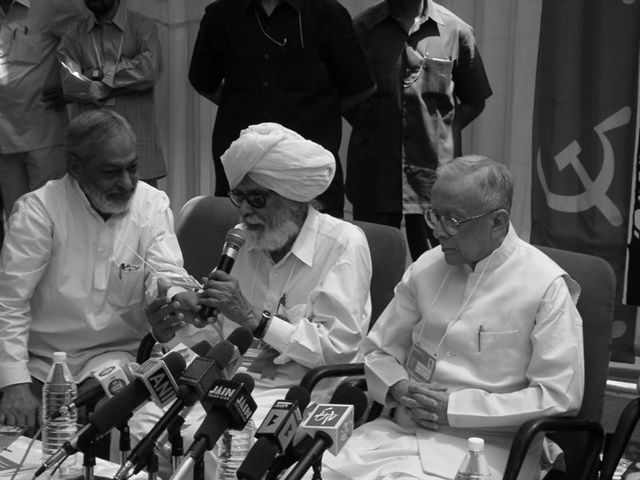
left=286, top=384, right=367, bottom=480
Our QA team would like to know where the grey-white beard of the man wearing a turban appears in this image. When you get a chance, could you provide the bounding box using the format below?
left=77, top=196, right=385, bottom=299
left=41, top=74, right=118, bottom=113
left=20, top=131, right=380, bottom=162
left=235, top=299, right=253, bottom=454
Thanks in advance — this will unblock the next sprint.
left=242, top=199, right=307, bottom=252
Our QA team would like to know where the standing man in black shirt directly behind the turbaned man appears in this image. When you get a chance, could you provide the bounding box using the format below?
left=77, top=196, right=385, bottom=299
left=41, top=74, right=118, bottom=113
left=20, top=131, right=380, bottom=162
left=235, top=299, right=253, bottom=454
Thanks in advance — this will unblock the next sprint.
left=189, top=0, right=375, bottom=217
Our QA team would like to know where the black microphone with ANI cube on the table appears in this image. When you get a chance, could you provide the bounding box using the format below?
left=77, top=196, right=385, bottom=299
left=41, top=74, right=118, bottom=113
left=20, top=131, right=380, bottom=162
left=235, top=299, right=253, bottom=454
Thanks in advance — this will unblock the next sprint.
left=34, top=353, right=186, bottom=478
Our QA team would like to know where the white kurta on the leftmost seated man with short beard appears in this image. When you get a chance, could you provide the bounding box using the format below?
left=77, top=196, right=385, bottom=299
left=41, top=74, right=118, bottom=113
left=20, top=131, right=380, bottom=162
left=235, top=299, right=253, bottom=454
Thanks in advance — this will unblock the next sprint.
left=0, top=175, right=187, bottom=388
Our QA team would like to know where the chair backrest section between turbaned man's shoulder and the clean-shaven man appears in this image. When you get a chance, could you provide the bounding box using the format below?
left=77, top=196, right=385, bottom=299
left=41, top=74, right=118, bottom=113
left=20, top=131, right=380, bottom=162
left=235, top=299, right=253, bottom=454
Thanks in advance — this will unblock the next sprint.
left=352, top=220, right=407, bottom=329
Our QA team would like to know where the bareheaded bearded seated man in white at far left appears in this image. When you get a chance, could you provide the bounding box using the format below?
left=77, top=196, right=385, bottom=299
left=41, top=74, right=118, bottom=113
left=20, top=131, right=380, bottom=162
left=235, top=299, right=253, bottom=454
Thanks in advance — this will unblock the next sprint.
left=0, top=110, right=199, bottom=429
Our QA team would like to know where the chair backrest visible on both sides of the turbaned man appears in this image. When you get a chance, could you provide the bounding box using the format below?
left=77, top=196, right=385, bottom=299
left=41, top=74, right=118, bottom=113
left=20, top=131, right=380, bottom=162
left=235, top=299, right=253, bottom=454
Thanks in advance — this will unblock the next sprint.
left=175, top=196, right=407, bottom=325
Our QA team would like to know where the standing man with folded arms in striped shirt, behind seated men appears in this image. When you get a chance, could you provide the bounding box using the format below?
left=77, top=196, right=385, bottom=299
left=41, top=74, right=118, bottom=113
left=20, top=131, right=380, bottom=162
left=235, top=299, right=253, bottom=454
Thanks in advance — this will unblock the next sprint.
left=58, top=0, right=167, bottom=186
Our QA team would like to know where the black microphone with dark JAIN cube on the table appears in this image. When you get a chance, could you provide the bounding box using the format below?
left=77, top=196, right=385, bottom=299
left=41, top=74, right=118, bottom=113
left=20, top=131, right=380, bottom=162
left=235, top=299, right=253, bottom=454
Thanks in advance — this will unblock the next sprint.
left=170, top=373, right=256, bottom=480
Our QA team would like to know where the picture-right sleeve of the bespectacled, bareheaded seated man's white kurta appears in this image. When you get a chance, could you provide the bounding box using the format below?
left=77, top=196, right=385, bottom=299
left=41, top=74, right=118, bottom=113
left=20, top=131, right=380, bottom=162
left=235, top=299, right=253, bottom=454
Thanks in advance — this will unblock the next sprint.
left=447, top=277, right=584, bottom=428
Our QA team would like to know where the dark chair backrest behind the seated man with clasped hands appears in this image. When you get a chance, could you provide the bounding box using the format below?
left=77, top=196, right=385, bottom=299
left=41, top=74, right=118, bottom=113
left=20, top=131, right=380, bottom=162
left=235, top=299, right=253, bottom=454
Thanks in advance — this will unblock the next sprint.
left=539, top=247, right=616, bottom=478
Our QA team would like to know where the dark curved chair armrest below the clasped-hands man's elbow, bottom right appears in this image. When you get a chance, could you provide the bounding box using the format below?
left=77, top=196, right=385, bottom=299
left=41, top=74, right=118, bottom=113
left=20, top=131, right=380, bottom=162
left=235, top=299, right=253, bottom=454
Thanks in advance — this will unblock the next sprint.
left=502, top=417, right=604, bottom=480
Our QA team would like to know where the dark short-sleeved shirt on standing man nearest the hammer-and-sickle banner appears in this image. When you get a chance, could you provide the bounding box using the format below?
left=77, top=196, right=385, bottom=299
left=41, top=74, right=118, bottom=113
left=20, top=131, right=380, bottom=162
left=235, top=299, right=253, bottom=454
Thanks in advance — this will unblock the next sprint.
left=346, top=0, right=492, bottom=213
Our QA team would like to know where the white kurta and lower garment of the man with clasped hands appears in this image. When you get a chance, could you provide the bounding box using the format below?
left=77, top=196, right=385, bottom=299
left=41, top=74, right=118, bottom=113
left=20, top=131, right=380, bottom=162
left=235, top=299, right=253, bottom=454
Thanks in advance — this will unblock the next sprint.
left=325, top=227, right=584, bottom=480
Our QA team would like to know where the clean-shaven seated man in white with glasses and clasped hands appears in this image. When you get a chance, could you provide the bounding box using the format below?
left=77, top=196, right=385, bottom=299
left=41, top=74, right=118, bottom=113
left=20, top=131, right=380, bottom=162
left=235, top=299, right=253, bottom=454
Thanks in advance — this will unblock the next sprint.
left=323, top=155, right=584, bottom=480
